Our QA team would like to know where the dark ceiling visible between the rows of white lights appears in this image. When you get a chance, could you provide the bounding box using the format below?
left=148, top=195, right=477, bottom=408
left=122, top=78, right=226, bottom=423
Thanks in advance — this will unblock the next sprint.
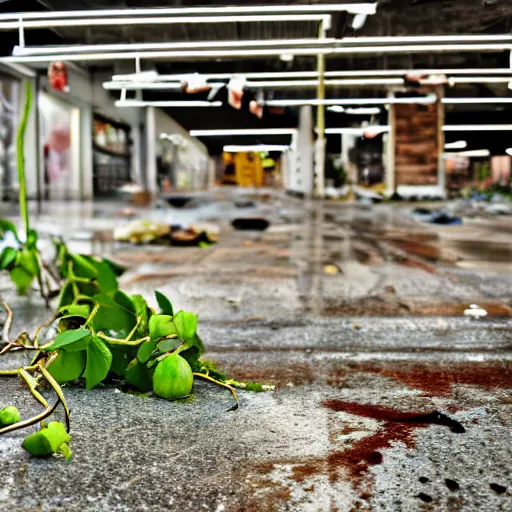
left=0, top=0, right=512, bottom=152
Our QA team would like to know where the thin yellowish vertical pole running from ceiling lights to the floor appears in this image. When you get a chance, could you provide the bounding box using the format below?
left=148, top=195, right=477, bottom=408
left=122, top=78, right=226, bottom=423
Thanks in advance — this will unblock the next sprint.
left=314, top=21, right=326, bottom=197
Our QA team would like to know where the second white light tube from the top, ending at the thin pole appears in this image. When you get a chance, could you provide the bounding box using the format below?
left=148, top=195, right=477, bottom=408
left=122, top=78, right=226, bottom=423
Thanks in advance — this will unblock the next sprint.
left=0, top=13, right=330, bottom=30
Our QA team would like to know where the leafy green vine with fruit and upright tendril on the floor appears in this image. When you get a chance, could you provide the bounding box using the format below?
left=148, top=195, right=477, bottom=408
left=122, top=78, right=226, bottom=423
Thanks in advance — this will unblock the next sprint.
left=0, top=81, right=274, bottom=459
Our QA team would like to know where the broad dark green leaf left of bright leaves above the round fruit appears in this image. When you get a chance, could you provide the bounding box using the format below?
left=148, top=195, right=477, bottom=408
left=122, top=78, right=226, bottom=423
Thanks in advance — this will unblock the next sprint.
left=91, top=291, right=136, bottom=334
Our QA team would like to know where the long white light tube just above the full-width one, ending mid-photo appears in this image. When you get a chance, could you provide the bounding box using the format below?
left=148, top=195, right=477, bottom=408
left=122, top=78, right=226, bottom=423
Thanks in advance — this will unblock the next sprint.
left=12, top=38, right=335, bottom=56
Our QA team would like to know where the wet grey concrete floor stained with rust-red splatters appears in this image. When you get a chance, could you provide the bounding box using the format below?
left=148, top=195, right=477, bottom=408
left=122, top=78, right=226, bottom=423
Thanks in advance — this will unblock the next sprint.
left=0, top=190, right=512, bottom=512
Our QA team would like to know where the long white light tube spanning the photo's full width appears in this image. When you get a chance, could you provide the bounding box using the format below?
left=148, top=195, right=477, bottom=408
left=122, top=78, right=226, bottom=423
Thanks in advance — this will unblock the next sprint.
left=5, top=43, right=512, bottom=63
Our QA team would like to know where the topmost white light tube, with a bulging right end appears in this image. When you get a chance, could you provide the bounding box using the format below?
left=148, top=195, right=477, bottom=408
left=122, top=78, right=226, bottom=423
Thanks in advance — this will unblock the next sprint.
left=0, top=2, right=377, bottom=22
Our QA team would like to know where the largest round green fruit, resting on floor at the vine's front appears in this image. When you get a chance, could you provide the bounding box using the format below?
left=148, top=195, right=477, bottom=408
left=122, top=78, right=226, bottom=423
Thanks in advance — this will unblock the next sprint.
left=153, top=354, right=194, bottom=400
